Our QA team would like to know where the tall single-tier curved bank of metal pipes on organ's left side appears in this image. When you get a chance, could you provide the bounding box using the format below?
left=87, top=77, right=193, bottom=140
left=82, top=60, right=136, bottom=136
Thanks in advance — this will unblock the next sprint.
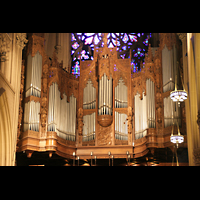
left=48, top=83, right=76, bottom=141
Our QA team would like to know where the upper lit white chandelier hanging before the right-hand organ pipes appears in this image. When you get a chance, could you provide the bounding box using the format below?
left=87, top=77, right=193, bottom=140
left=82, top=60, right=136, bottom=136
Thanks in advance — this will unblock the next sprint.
left=170, top=61, right=187, bottom=105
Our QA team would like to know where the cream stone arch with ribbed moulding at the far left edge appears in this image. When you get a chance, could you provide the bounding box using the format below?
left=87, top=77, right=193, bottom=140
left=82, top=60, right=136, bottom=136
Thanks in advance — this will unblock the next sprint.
left=0, top=88, right=12, bottom=166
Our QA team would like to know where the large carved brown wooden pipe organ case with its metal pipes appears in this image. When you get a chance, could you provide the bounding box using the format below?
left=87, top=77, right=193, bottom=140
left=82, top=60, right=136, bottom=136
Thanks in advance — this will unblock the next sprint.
left=17, top=33, right=187, bottom=164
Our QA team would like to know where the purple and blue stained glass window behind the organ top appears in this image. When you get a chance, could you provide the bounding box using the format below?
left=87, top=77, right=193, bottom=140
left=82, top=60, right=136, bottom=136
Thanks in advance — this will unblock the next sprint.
left=71, top=33, right=151, bottom=77
